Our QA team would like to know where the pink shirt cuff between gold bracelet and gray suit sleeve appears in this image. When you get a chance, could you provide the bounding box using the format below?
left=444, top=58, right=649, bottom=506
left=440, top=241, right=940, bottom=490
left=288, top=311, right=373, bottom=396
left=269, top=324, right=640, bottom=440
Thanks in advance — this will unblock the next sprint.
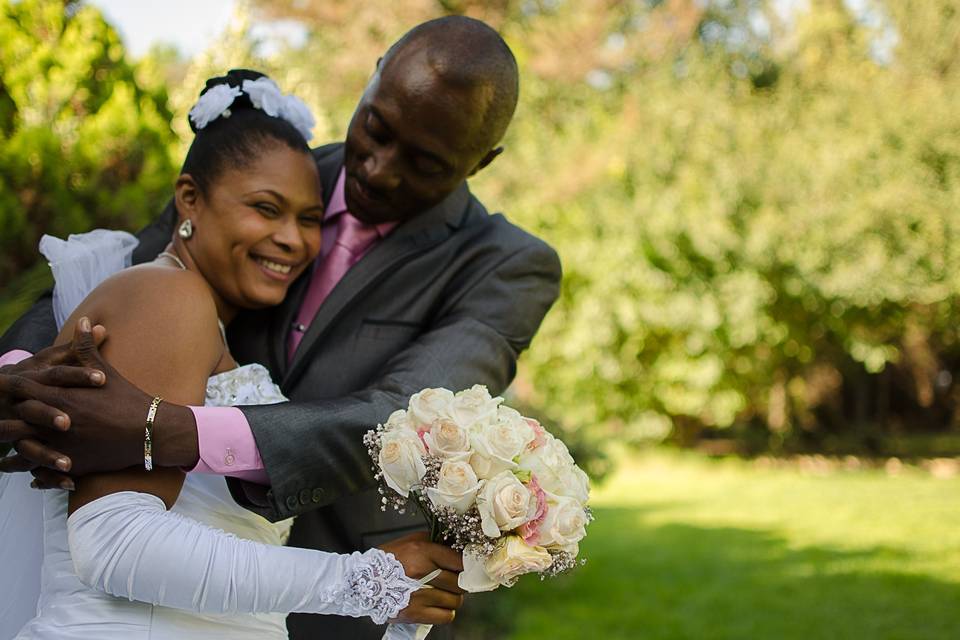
left=190, top=407, right=270, bottom=485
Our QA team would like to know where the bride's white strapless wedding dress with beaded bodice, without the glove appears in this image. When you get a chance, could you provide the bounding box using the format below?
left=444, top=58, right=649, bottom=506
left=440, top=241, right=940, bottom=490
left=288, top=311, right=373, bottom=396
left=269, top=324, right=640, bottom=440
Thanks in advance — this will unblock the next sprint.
left=17, top=364, right=292, bottom=640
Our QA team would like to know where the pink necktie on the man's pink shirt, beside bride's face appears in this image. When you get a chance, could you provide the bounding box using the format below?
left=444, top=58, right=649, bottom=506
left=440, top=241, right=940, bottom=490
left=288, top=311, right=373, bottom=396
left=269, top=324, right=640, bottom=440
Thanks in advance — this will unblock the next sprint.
left=287, top=212, right=378, bottom=360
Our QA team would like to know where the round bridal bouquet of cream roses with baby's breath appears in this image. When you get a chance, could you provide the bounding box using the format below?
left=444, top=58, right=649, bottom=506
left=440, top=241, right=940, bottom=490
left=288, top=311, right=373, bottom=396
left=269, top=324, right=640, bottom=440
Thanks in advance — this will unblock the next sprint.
left=364, top=385, right=592, bottom=592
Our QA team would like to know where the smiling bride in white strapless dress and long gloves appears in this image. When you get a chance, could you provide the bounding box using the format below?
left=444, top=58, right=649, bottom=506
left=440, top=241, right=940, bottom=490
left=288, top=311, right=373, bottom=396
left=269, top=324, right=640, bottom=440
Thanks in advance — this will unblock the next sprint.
left=11, top=71, right=461, bottom=640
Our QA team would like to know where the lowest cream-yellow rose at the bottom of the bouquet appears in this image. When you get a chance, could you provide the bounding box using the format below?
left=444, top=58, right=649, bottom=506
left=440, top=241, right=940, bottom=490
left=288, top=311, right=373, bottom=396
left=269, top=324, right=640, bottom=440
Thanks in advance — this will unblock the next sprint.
left=457, top=536, right=553, bottom=593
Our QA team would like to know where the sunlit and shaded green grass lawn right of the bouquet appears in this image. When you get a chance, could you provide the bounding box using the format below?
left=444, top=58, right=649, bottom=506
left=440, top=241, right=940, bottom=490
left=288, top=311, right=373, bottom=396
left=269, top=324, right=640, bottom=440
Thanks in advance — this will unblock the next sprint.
left=458, top=451, right=960, bottom=640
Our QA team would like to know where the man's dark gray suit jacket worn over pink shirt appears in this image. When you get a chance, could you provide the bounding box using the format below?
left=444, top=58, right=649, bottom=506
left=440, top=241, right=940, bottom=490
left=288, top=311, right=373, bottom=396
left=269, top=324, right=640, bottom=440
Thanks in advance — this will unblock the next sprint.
left=0, top=144, right=560, bottom=638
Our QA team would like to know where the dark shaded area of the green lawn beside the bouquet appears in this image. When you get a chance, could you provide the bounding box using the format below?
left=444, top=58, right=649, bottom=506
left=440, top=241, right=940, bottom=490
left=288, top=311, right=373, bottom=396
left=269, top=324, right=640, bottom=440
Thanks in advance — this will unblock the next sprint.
left=456, top=508, right=960, bottom=640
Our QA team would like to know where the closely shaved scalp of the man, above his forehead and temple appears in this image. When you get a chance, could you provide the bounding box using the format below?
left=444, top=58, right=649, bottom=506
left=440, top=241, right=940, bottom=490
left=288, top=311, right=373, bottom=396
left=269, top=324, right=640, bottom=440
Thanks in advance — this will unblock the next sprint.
left=381, top=16, right=520, bottom=150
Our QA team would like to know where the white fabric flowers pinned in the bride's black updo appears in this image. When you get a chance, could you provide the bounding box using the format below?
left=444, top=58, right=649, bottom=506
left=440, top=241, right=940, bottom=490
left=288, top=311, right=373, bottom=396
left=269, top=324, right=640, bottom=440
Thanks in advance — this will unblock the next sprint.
left=189, top=76, right=316, bottom=142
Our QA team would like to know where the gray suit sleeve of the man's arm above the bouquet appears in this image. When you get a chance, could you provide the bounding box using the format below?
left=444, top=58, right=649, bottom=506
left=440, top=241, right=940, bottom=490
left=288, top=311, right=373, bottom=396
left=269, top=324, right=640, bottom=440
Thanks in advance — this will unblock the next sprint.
left=230, top=241, right=561, bottom=519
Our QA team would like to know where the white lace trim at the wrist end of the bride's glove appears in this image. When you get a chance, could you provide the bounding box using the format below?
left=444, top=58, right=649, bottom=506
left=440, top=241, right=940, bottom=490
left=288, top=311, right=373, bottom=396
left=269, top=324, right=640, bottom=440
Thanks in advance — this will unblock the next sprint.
left=343, top=549, right=420, bottom=624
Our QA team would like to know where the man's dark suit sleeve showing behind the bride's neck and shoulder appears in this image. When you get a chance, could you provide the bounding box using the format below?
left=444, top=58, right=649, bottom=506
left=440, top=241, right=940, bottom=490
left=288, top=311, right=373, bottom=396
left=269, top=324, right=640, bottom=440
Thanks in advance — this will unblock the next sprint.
left=0, top=200, right=177, bottom=353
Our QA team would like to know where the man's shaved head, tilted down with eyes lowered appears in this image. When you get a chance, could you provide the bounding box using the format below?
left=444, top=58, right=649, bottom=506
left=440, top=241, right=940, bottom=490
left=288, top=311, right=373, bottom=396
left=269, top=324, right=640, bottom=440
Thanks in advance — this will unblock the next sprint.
left=344, top=16, right=519, bottom=224
